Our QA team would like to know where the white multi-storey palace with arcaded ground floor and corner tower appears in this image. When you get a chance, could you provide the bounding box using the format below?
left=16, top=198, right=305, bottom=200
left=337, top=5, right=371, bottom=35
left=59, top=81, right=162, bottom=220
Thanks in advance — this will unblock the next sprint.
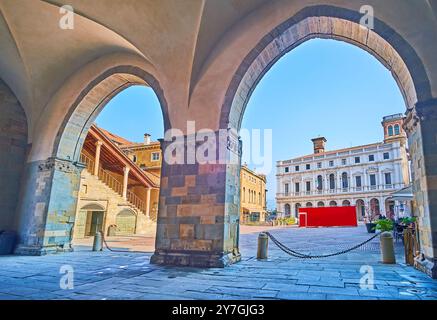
left=276, top=114, right=410, bottom=220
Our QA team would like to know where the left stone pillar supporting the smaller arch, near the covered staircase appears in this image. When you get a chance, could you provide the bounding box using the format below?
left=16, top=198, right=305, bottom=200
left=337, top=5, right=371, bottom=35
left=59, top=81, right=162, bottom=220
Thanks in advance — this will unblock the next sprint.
left=15, top=158, right=84, bottom=255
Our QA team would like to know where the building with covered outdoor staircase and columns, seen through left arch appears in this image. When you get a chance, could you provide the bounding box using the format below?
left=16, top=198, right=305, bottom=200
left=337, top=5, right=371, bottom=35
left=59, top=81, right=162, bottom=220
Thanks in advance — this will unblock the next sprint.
left=73, top=125, right=159, bottom=239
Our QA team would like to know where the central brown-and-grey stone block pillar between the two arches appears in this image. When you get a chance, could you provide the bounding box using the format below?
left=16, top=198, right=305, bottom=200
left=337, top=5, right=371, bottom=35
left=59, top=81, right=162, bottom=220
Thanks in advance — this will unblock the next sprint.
left=151, top=132, right=241, bottom=267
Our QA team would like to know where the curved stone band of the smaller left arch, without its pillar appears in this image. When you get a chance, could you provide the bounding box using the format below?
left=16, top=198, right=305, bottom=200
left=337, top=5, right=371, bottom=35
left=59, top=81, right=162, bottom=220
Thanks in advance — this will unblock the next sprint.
left=53, top=65, right=171, bottom=161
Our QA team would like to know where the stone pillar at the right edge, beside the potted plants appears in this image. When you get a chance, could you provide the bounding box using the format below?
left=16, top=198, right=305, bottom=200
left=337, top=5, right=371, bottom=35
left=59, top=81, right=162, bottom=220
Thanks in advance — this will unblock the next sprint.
left=404, top=99, right=437, bottom=278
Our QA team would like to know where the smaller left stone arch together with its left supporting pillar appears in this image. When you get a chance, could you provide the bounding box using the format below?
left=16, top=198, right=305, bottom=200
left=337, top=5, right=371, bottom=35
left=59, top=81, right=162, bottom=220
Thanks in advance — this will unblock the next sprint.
left=15, top=64, right=167, bottom=255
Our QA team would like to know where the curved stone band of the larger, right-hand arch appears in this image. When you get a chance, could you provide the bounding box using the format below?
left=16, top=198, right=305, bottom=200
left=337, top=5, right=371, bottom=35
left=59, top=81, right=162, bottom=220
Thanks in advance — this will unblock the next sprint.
left=219, top=5, right=432, bottom=130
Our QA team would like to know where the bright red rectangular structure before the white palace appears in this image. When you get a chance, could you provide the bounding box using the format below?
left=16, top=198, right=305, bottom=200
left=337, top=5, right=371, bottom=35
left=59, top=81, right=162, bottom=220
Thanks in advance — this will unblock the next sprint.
left=299, top=206, right=357, bottom=227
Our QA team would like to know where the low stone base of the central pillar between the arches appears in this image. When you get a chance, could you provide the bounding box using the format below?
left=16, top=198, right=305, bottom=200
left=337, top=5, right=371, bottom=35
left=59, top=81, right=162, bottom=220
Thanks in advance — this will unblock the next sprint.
left=150, top=250, right=241, bottom=268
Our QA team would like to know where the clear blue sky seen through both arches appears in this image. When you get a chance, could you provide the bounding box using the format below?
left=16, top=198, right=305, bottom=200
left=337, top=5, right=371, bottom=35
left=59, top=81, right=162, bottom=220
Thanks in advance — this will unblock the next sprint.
left=93, top=39, right=405, bottom=208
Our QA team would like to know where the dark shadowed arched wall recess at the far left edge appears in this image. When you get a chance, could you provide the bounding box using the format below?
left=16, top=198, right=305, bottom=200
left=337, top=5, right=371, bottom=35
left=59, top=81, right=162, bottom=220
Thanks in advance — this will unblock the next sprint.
left=0, top=78, right=28, bottom=231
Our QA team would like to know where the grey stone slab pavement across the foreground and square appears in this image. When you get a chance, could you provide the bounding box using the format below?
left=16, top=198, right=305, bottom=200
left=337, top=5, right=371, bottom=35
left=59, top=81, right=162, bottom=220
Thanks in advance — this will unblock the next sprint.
left=0, top=226, right=437, bottom=300
